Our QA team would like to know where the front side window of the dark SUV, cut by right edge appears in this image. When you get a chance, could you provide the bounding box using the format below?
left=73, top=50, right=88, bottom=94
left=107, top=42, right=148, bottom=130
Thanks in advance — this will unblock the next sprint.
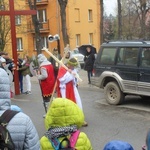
left=141, top=48, right=150, bottom=67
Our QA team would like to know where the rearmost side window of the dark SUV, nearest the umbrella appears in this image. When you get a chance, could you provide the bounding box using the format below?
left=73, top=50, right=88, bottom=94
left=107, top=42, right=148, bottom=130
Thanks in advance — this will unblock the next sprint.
left=100, top=48, right=117, bottom=65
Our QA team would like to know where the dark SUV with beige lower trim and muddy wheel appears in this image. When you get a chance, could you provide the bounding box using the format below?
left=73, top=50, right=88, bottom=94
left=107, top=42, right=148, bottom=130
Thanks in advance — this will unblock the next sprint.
left=91, top=41, right=150, bottom=105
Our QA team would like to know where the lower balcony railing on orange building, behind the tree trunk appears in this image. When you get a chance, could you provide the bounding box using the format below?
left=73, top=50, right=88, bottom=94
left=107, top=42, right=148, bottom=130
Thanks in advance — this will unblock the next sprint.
left=27, top=20, right=50, bottom=33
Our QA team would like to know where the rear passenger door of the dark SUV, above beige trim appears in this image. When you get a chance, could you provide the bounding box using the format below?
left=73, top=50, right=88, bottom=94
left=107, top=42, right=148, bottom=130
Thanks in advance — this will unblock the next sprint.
left=115, top=47, right=139, bottom=93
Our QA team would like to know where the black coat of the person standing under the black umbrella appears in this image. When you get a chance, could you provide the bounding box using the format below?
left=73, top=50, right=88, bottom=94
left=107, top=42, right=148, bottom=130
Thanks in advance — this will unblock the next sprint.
left=84, top=53, right=95, bottom=71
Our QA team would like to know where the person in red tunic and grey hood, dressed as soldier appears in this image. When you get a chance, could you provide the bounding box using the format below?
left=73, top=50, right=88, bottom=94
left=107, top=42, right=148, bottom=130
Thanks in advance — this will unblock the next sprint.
left=37, top=54, right=55, bottom=112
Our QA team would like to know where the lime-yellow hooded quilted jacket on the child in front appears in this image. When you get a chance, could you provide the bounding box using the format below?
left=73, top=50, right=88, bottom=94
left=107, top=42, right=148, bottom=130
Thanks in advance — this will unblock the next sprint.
left=40, top=98, right=92, bottom=150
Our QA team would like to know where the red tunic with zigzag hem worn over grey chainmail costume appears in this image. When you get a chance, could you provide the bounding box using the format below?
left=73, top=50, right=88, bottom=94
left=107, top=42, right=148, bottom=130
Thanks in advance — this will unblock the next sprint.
left=41, top=64, right=55, bottom=97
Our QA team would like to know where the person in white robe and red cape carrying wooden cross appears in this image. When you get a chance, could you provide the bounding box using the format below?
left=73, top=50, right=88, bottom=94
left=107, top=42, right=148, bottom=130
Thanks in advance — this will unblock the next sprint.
left=57, top=58, right=87, bottom=126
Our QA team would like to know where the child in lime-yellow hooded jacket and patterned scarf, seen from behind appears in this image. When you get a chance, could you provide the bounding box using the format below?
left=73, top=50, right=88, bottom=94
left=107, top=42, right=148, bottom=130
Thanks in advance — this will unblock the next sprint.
left=40, top=98, right=93, bottom=150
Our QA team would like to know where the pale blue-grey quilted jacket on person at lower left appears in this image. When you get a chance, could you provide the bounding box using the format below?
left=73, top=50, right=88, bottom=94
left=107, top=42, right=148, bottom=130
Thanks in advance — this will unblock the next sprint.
left=0, top=68, right=40, bottom=150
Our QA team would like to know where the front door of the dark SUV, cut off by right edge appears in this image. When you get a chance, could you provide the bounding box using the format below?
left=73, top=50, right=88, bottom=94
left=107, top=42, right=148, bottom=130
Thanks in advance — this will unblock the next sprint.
left=138, top=48, right=150, bottom=96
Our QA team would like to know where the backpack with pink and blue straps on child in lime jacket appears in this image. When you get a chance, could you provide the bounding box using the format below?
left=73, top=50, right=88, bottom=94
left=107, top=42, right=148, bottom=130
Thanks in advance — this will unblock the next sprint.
left=51, top=130, right=80, bottom=150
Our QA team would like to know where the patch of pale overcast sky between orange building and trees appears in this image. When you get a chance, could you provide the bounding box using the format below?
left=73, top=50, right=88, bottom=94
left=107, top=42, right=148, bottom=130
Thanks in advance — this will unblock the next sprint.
left=103, top=0, right=117, bottom=15
